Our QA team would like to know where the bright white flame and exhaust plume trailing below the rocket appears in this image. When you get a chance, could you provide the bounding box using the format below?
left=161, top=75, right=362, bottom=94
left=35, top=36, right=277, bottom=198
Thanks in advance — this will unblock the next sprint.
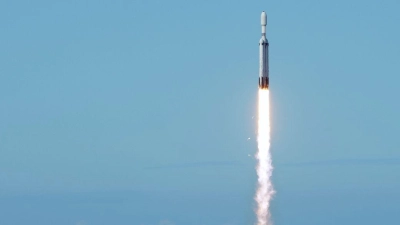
left=255, top=89, right=274, bottom=225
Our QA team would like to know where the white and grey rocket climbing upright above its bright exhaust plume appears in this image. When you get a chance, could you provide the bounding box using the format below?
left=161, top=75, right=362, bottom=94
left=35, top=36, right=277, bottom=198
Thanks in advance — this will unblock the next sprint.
left=258, top=11, right=269, bottom=89
